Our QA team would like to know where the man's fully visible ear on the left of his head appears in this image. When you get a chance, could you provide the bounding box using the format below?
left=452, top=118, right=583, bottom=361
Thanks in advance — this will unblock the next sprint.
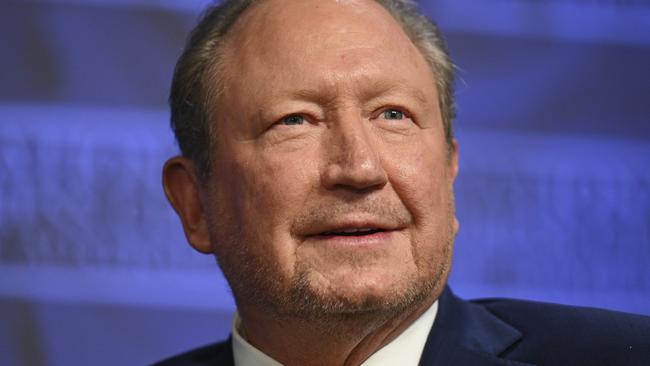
left=162, top=156, right=212, bottom=254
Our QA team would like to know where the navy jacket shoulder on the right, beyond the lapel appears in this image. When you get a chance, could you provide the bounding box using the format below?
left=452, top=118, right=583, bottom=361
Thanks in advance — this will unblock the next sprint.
left=472, top=299, right=650, bottom=365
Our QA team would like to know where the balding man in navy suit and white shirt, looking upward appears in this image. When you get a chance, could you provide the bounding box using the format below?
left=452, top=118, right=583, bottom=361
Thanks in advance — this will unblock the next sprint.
left=161, top=0, right=650, bottom=365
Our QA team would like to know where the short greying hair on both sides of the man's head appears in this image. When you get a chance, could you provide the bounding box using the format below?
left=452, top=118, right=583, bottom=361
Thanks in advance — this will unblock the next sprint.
left=169, top=0, right=456, bottom=182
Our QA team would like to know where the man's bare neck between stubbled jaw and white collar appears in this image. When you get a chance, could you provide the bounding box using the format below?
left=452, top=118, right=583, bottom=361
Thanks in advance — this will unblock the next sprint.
left=239, top=296, right=435, bottom=366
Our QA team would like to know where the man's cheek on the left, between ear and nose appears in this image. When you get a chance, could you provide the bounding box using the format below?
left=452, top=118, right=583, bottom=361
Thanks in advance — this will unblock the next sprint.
left=212, top=148, right=316, bottom=270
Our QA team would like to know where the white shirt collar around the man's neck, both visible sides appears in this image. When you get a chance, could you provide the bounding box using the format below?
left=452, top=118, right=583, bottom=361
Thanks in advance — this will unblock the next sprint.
left=231, top=301, right=438, bottom=366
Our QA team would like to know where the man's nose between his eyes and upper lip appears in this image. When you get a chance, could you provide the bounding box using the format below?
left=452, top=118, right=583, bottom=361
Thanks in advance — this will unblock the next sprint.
left=321, top=117, right=388, bottom=191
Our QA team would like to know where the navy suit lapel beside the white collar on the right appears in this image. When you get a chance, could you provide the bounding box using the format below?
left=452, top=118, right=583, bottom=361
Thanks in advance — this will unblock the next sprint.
left=420, top=288, right=530, bottom=366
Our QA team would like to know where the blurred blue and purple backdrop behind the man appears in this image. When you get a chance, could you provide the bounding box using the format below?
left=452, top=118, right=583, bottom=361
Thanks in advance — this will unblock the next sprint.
left=0, top=0, right=650, bottom=365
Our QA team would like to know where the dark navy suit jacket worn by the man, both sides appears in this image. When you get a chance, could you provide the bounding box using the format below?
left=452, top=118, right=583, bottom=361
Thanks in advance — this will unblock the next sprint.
left=156, top=288, right=650, bottom=366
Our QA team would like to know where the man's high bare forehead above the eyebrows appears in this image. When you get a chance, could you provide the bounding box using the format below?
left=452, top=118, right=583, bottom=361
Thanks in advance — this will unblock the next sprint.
left=216, top=0, right=435, bottom=110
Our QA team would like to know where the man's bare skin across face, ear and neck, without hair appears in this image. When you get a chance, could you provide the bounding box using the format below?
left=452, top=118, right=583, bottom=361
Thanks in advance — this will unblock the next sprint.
left=163, top=0, right=458, bottom=365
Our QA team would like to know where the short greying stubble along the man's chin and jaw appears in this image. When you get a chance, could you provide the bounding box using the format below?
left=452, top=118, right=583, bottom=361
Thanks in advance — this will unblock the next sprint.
left=222, top=232, right=453, bottom=328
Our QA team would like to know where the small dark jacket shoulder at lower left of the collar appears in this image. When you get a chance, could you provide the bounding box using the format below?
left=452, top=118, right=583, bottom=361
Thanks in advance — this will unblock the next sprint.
left=152, top=339, right=234, bottom=366
